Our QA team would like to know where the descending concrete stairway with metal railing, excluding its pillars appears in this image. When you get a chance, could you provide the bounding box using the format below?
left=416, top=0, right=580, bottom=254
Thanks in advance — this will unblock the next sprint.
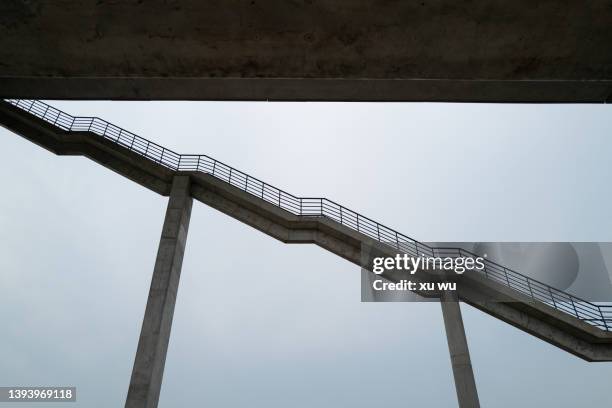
left=0, top=100, right=612, bottom=361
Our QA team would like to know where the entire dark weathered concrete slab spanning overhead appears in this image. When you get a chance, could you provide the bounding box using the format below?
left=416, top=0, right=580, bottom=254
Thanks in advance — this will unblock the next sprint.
left=0, top=0, right=612, bottom=102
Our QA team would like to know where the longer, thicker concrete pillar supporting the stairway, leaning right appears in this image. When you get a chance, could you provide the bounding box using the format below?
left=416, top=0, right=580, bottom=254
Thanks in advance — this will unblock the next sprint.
left=125, top=176, right=193, bottom=408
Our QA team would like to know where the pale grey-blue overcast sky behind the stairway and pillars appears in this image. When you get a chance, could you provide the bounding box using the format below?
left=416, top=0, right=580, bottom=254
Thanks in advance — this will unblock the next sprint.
left=0, top=102, right=612, bottom=408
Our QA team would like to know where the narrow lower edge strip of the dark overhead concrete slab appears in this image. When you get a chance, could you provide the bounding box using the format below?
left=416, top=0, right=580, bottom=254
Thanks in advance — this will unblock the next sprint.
left=0, top=77, right=612, bottom=103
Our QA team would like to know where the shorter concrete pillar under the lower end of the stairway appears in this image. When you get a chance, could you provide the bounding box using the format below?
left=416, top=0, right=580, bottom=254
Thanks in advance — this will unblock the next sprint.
left=440, top=291, right=480, bottom=408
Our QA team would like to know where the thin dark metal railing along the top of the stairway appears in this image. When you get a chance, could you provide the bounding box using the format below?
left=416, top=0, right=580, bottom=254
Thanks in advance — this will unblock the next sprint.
left=5, top=99, right=612, bottom=331
